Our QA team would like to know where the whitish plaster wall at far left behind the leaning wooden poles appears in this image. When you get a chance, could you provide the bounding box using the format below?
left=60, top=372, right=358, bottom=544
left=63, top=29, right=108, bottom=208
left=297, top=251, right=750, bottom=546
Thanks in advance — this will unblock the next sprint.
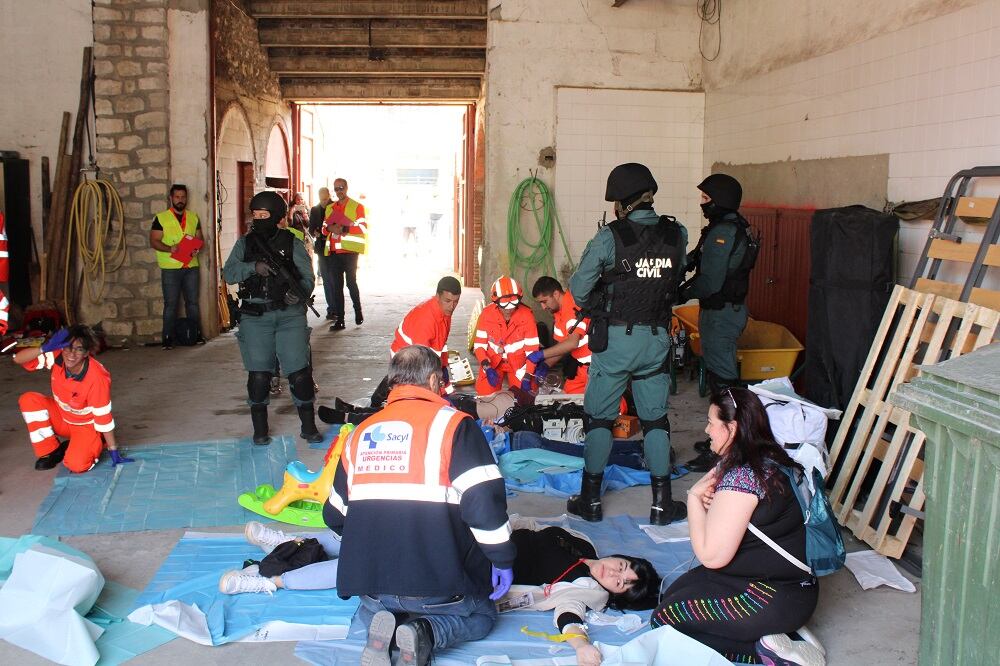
left=0, top=0, right=94, bottom=258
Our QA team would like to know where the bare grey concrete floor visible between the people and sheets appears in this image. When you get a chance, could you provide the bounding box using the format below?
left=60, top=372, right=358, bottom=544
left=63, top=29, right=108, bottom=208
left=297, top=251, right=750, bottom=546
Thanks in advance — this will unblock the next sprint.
left=0, top=280, right=920, bottom=666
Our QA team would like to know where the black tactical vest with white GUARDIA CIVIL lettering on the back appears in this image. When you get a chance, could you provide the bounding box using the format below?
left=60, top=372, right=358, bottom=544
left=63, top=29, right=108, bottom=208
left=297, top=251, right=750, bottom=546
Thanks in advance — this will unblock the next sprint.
left=602, top=215, right=684, bottom=326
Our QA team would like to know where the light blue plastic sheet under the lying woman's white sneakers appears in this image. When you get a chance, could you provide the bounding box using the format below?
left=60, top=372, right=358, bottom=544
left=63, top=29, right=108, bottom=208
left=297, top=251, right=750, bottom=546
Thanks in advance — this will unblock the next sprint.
left=133, top=533, right=358, bottom=645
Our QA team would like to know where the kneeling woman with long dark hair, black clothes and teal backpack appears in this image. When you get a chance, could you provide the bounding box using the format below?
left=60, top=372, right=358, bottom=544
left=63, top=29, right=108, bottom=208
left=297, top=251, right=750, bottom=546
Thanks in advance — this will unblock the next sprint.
left=651, top=388, right=824, bottom=666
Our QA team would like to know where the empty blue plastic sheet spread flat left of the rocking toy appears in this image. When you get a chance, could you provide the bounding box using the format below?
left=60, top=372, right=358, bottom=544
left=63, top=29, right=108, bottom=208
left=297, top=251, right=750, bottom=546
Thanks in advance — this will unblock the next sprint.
left=32, top=436, right=295, bottom=536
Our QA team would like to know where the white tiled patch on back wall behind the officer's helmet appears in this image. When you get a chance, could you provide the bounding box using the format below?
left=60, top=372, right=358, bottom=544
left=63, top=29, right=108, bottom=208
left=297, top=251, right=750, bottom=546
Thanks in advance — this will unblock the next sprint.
left=554, top=88, right=705, bottom=267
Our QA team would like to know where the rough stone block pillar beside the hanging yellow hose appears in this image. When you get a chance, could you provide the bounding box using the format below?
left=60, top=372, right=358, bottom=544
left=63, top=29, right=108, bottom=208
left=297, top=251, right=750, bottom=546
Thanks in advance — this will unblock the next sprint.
left=93, top=0, right=170, bottom=342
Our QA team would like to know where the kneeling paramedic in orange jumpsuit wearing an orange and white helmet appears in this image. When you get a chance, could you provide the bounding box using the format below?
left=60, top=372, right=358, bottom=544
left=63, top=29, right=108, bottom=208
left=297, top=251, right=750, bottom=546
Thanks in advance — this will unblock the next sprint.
left=472, top=275, right=538, bottom=395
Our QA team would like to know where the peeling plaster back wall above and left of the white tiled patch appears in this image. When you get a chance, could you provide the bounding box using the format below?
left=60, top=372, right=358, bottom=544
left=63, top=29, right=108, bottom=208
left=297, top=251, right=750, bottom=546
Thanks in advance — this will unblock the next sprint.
left=481, top=0, right=701, bottom=289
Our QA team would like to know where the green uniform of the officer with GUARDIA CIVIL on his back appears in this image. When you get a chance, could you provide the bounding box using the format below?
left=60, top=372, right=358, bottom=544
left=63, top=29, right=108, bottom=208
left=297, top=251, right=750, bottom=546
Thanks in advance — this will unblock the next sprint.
left=569, top=209, right=687, bottom=476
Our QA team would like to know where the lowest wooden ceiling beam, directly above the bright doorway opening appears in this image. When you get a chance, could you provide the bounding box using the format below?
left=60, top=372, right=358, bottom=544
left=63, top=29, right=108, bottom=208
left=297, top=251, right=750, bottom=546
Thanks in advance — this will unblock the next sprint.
left=280, top=76, right=482, bottom=103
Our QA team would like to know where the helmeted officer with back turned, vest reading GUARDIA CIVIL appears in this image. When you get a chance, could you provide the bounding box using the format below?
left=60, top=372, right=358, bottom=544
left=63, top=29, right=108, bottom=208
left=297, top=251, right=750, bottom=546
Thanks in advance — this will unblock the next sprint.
left=566, top=163, right=687, bottom=525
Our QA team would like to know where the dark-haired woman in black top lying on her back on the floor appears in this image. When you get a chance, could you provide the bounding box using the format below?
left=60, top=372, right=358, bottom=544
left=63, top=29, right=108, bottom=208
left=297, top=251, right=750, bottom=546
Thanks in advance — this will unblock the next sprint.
left=219, top=518, right=660, bottom=666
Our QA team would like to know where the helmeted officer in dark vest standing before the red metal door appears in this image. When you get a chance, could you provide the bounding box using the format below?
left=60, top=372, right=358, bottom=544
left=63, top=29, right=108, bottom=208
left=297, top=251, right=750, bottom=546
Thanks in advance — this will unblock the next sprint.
left=680, top=173, right=756, bottom=393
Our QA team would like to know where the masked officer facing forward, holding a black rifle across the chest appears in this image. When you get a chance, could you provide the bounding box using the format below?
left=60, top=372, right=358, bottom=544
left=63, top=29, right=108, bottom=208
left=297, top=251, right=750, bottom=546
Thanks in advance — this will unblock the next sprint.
left=222, top=192, right=322, bottom=444
